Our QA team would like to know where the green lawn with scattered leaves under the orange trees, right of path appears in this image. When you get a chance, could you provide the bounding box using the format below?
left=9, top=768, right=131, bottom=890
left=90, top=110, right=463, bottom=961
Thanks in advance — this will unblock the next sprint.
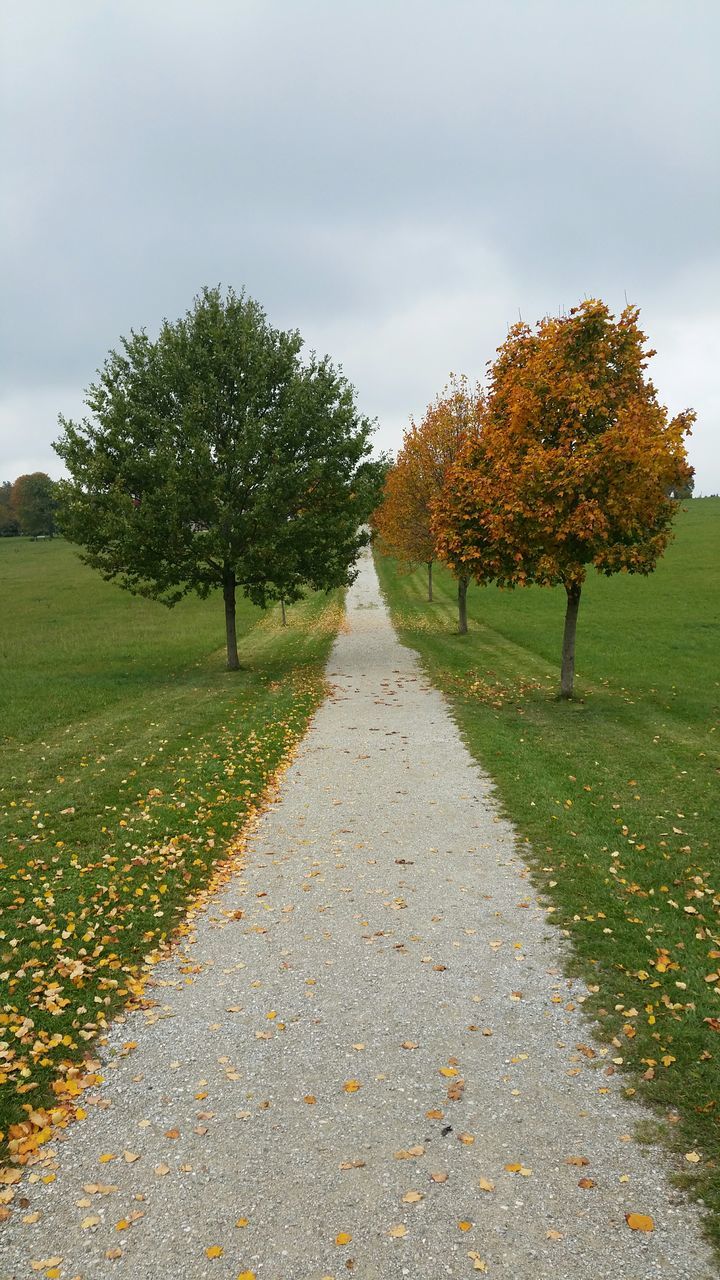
left=377, top=498, right=720, bottom=1244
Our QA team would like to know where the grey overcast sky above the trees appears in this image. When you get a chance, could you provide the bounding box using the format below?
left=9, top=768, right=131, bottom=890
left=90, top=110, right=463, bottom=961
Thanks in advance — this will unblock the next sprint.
left=0, top=0, right=720, bottom=493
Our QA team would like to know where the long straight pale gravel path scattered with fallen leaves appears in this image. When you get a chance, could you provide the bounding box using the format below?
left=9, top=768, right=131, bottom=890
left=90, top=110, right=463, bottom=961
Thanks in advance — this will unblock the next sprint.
left=0, top=557, right=716, bottom=1280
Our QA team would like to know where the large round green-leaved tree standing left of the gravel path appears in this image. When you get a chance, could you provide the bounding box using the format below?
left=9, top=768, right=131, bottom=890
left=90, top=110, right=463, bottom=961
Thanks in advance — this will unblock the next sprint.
left=55, top=288, right=373, bottom=669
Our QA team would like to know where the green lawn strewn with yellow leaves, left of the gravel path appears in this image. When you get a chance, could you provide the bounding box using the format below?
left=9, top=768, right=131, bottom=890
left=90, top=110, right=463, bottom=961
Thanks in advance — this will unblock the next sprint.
left=0, top=539, right=342, bottom=1158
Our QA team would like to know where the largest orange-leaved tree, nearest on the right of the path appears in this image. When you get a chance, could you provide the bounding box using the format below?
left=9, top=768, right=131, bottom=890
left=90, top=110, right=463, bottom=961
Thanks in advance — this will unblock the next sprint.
left=433, top=300, right=694, bottom=698
